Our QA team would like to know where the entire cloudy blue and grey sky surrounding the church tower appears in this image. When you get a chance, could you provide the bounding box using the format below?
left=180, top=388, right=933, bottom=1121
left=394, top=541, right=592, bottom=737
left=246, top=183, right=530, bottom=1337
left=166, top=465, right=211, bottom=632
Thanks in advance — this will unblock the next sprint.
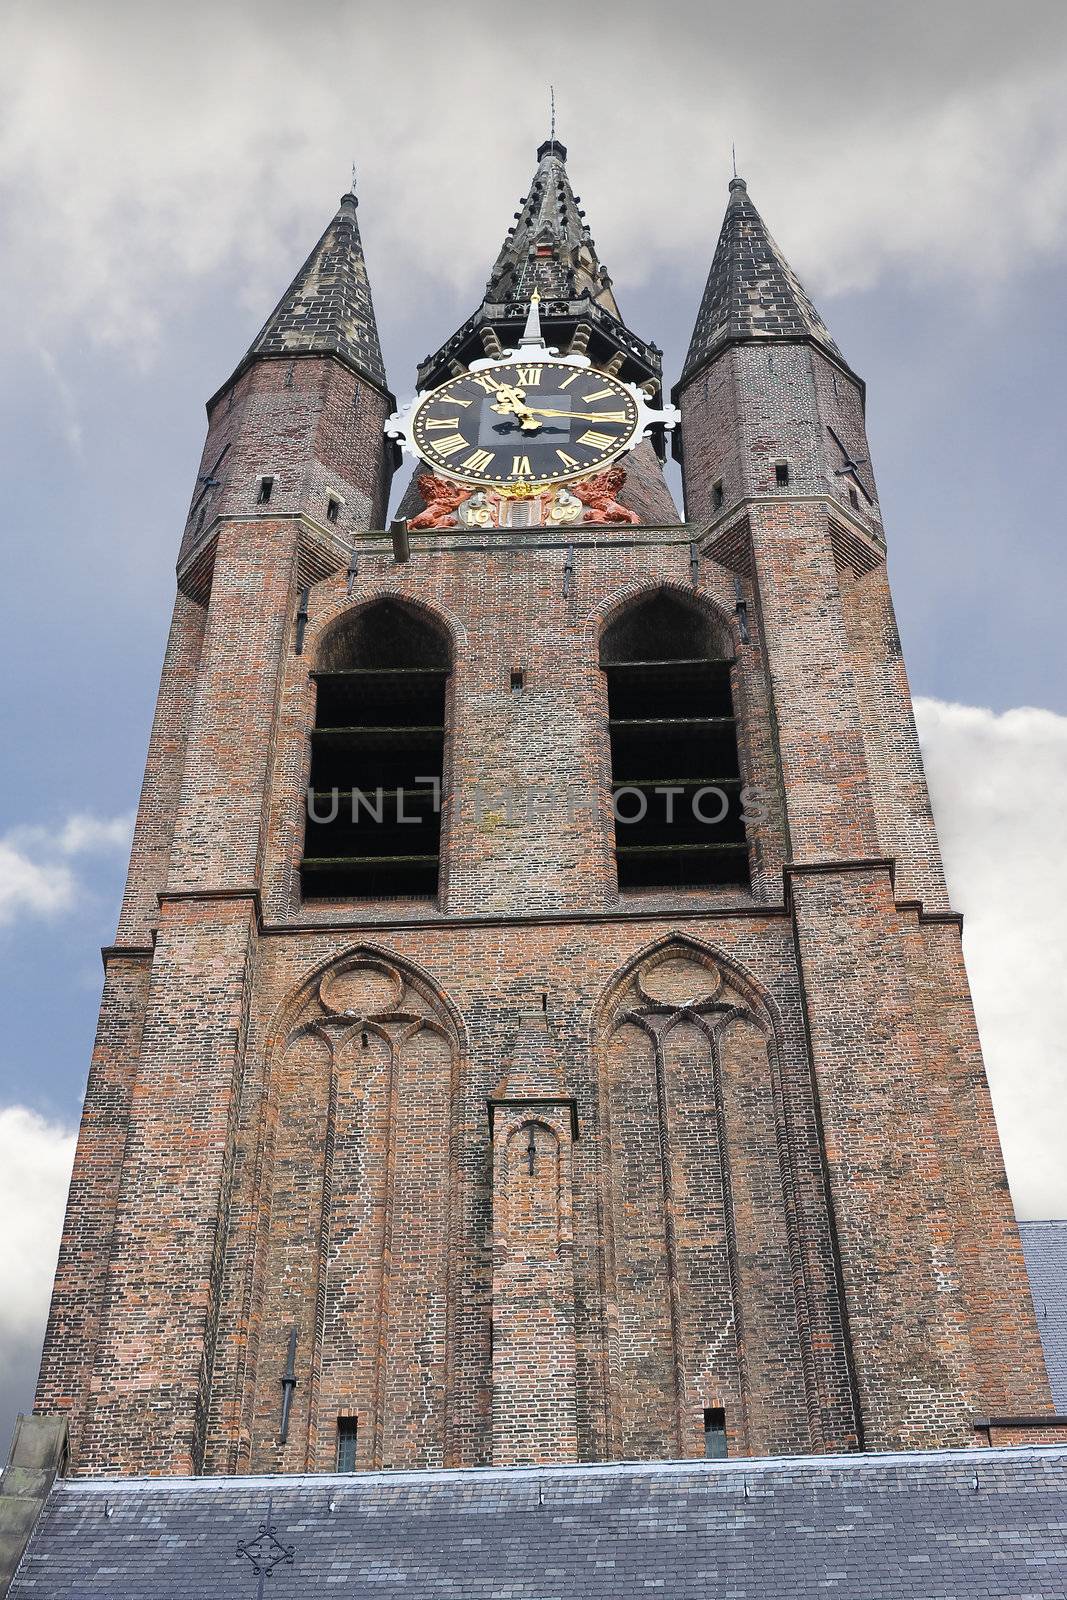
left=0, top=0, right=1067, bottom=1451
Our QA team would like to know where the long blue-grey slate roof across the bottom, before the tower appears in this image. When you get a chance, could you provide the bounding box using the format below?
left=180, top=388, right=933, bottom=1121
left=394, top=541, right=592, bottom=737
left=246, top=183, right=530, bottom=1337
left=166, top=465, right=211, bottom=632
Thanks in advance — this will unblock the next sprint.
left=11, top=1446, right=1067, bottom=1600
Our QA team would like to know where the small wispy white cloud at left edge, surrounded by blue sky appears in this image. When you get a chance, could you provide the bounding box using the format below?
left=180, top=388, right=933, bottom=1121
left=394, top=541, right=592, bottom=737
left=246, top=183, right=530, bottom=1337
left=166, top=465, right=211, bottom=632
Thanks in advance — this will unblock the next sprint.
left=0, top=813, right=133, bottom=923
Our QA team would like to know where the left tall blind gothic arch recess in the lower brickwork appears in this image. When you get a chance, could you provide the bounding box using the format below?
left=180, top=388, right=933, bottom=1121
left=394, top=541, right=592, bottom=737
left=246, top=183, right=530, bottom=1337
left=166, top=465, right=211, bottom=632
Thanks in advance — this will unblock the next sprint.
left=251, top=949, right=461, bottom=1472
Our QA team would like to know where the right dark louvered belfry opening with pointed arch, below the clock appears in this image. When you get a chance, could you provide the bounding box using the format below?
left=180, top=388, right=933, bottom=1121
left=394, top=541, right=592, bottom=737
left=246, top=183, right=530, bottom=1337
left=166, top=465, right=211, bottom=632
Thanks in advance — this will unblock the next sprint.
left=600, top=594, right=749, bottom=890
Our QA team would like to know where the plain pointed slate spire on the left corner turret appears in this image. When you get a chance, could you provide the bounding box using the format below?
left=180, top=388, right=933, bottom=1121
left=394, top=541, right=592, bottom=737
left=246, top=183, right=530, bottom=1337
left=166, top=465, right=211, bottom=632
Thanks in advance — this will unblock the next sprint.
left=246, top=192, right=387, bottom=390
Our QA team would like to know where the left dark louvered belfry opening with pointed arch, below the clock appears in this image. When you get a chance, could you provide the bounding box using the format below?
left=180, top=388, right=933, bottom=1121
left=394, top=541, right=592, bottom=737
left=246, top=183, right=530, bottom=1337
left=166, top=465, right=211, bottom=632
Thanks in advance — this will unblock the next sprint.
left=301, top=600, right=450, bottom=899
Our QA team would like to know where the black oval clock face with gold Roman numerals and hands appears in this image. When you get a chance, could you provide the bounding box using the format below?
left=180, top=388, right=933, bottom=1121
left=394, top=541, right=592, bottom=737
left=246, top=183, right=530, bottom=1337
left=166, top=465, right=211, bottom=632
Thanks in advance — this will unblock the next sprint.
left=411, top=360, right=640, bottom=485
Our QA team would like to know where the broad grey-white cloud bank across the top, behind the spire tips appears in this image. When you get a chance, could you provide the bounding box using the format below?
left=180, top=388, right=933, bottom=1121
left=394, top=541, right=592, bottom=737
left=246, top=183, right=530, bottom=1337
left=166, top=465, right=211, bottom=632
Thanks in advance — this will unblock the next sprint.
left=0, top=0, right=1067, bottom=352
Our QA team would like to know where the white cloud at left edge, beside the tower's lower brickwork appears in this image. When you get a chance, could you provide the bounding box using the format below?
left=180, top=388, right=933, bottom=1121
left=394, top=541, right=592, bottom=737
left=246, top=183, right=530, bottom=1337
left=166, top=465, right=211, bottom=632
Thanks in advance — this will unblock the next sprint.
left=0, top=1106, right=75, bottom=1370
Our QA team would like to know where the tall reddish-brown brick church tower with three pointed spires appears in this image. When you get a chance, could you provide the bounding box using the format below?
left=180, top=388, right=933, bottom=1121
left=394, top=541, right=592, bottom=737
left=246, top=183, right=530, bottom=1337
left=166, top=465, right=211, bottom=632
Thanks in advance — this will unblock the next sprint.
left=37, top=150, right=1051, bottom=1472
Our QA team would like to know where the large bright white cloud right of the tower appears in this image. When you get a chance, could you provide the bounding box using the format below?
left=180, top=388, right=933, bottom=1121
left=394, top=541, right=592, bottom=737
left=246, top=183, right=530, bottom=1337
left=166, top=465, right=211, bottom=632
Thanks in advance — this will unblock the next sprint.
left=915, top=699, right=1067, bottom=1218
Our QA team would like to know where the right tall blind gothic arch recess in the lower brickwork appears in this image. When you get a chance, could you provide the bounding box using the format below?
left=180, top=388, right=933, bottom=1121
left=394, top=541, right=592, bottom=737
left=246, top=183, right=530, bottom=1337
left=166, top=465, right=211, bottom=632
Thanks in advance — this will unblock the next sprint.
left=597, top=939, right=813, bottom=1459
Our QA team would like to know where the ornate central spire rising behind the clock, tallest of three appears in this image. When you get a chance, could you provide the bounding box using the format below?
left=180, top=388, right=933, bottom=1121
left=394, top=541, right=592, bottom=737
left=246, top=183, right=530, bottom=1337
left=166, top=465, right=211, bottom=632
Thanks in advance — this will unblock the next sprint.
left=418, top=138, right=662, bottom=406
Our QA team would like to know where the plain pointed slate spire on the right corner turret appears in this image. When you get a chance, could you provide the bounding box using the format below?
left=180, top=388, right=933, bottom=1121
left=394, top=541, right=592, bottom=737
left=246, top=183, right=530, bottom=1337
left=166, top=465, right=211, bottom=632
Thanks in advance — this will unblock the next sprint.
left=681, top=176, right=845, bottom=384
